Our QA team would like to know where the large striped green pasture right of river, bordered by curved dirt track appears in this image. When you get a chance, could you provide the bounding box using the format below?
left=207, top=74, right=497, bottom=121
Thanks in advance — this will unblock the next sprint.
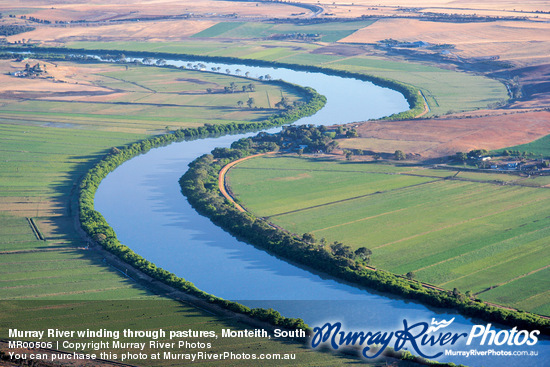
left=229, top=156, right=550, bottom=314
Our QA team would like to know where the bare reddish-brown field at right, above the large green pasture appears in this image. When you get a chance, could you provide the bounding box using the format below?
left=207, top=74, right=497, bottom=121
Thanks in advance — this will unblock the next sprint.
left=339, top=111, right=550, bottom=158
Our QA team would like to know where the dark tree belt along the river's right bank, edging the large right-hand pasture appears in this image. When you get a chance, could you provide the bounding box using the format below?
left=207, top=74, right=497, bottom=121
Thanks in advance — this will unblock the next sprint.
left=180, top=127, right=550, bottom=333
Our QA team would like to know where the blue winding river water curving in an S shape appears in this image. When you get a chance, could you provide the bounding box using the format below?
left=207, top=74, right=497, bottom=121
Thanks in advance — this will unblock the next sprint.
left=95, top=60, right=550, bottom=367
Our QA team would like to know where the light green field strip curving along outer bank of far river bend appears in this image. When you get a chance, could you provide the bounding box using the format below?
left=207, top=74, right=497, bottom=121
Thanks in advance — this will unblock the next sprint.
left=68, top=40, right=508, bottom=116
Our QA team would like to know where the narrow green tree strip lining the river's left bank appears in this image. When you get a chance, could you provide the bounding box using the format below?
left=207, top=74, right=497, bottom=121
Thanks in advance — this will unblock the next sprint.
left=79, top=86, right=326, bottom=328
